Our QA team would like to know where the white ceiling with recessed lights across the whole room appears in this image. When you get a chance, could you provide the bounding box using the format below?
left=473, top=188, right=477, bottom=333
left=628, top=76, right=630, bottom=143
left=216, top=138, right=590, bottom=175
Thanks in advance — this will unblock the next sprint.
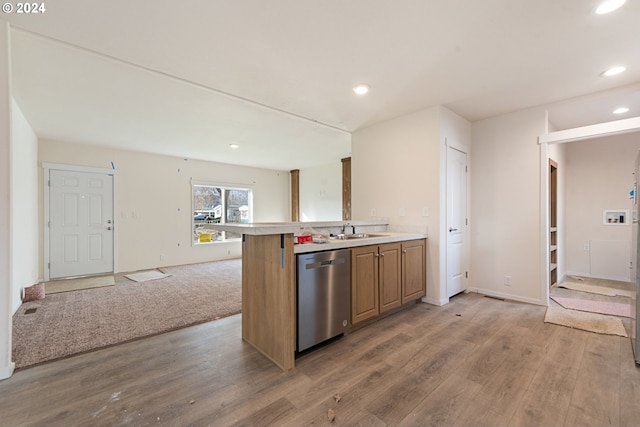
left=3, top=0, right=640, bottom=170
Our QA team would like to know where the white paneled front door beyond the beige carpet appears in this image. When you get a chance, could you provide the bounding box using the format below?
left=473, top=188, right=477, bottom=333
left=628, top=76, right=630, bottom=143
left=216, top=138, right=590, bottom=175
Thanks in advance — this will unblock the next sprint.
left=49, top=169, right=114, bottom=279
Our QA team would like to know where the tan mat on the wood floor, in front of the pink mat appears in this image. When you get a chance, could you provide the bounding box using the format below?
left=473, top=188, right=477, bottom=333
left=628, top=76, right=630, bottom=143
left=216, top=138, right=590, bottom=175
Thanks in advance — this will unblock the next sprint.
left=544, top=307, right=628, bottom=337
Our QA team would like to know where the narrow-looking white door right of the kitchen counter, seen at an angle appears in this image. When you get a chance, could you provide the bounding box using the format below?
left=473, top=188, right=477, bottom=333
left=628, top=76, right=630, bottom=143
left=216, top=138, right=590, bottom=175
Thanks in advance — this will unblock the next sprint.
left=447, top=147, right=467, bottom=297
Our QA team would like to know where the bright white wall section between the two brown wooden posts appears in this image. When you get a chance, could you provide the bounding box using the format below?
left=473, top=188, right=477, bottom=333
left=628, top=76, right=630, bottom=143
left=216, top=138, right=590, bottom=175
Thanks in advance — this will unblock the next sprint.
left=300, top=162, right=342, bottom=221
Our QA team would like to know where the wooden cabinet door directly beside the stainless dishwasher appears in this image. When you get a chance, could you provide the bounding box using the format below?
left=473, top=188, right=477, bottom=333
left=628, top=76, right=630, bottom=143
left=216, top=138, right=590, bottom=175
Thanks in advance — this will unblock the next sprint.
left=351, top=246, right=379, bottom=324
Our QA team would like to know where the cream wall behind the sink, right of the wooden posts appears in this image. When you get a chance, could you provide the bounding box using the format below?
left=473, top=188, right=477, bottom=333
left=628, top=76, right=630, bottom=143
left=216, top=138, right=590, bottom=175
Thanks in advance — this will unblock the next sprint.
left=351, top=107, right=442, bottom=302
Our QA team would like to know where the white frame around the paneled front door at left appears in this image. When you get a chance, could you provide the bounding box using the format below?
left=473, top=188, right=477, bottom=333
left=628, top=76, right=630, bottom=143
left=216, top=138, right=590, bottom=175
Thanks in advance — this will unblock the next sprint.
left=42, top=162, right=118, bottom=282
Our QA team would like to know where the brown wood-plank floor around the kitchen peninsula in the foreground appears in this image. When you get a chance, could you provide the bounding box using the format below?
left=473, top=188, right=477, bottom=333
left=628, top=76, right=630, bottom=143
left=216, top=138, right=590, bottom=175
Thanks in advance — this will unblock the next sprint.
left=0, top=294, right=640, bottom=427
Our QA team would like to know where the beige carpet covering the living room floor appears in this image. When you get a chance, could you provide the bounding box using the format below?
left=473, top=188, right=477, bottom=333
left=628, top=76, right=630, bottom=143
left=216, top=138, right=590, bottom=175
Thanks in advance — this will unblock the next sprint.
left=13, top=259, right=242, bottom=368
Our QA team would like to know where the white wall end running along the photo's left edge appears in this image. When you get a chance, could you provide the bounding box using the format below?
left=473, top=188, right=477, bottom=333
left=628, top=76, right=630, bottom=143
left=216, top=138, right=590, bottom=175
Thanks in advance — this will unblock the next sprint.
left=0, top=19, right=14, bottom=379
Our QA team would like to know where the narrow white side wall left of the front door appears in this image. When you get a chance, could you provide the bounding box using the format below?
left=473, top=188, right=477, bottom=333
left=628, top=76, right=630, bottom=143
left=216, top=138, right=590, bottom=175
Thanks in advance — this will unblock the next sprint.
left=11, top=101, right=41, bottom=313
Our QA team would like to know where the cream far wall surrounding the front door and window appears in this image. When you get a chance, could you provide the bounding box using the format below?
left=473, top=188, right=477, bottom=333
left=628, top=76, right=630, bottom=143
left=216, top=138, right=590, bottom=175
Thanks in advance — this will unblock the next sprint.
left=38, top=140, right=290, bottom=272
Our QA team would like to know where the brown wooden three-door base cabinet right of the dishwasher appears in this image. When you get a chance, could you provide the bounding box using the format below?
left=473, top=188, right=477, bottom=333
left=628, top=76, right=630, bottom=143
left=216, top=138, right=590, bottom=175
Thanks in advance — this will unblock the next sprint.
left=351, top=239, right=426, bottom=324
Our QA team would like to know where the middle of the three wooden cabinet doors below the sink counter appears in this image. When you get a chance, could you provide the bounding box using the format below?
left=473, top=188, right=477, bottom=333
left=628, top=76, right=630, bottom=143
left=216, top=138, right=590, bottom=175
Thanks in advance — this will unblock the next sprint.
left=378, top=243, right=402, bottom=313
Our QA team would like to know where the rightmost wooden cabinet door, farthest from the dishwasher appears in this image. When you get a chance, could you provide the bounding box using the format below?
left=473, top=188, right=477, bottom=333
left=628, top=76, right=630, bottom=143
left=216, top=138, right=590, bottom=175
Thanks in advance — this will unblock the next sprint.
left=402, top=239, right=427, bottom=304
